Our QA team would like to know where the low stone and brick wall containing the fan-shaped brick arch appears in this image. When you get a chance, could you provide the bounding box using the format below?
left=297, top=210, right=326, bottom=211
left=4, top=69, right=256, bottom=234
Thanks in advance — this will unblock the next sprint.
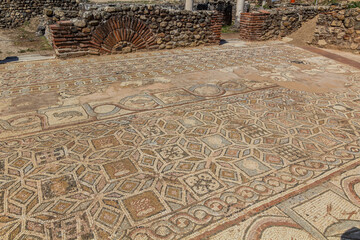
left=49, top=5, right=222, bottom=57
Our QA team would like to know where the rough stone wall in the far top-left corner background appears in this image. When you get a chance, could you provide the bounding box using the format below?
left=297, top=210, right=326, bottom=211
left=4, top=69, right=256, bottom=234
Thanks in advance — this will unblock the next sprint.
left=0, top=0, right=85, bottom=28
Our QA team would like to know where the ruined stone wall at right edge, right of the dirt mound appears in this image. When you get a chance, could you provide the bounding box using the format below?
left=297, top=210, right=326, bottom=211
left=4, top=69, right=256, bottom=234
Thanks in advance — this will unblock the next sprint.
left=312, top=8, right=360, bottom=51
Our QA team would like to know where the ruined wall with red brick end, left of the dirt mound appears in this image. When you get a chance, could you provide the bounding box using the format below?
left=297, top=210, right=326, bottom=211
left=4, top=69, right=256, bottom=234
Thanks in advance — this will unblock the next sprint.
left=240, top=6, right=334, bottom=41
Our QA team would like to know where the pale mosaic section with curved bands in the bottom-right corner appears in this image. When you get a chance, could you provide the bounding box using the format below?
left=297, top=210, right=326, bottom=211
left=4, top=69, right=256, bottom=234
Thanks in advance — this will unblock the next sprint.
left=210, top=164, right=360, bottom=240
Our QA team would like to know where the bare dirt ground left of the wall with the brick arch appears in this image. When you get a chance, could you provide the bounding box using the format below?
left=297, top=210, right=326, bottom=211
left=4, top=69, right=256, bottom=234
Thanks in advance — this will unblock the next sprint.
left=0, top=19, right=53, bottom=60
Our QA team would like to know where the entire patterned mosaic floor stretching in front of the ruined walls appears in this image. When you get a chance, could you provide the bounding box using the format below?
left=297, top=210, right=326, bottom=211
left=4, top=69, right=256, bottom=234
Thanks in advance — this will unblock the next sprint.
left=0, top=41, right=360, bottom=240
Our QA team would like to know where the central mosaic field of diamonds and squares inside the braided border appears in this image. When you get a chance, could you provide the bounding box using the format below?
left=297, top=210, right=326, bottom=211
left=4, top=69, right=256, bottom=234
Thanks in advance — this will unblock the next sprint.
left=0, top=84, right=359, bottom=238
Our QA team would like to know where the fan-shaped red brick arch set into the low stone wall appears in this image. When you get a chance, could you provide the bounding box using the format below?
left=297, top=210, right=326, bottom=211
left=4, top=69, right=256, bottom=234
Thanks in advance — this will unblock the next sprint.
left=92, top=16, right=156, bottom=53
